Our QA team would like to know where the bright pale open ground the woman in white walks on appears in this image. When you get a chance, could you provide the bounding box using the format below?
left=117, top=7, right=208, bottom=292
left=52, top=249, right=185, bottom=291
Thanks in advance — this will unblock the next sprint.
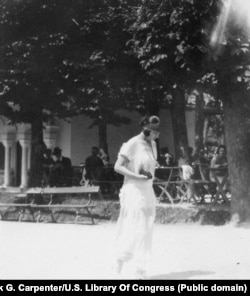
left=0, top=221, right=250, bottom=279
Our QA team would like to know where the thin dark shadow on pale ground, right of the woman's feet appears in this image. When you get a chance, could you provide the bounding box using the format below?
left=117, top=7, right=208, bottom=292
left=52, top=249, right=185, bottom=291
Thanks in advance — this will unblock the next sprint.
left=149, top=270, right=214, bottom=280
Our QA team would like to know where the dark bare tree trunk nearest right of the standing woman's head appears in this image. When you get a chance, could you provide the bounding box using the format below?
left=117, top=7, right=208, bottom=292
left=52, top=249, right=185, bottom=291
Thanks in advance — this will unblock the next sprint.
left=171, top=88, right=189, bottom=162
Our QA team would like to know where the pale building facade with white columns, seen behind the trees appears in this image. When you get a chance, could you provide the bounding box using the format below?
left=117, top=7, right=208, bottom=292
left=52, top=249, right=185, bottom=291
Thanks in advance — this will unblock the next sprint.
left=0, top=110, right=194, bottom=189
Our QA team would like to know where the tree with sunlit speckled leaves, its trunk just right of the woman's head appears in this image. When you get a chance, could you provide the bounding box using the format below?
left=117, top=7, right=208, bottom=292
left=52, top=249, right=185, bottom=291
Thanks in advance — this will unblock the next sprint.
left=127, top=0, right=219, bottom=162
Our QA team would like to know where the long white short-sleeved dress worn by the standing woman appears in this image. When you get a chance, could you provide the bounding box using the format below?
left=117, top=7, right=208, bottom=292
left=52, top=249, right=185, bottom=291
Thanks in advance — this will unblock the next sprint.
left=116, top=134, right=157, bottom=271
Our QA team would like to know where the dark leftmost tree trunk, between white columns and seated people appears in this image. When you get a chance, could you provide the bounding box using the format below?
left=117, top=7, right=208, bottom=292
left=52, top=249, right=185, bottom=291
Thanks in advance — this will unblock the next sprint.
left=29, top=116, right=44, bottom=187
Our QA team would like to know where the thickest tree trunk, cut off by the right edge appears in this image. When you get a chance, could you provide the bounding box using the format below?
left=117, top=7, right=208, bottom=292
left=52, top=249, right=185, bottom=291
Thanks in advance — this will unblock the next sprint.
left=224, top=92, right=250, bottom=222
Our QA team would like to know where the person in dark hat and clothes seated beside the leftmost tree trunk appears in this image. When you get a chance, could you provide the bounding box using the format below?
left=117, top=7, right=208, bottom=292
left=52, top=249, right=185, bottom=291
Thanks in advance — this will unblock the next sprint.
left=49, top=147, right=73, bottom=187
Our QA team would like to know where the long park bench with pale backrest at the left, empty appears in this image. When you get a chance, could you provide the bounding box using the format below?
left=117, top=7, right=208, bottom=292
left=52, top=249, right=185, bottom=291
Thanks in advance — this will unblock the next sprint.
left=0, top=186, right=100, bottom=224
